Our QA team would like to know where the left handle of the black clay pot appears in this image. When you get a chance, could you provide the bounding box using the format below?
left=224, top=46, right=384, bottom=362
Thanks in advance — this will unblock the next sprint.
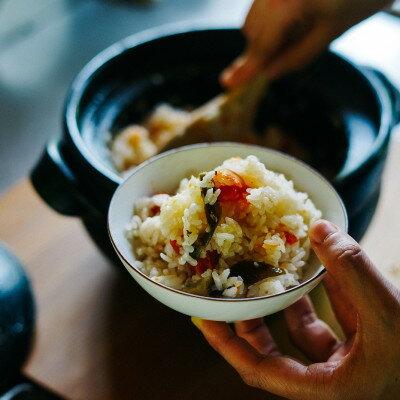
left=30, top=140, right=98, bottom=217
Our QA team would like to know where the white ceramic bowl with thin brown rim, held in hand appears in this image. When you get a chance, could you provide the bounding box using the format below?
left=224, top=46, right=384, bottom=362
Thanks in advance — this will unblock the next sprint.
left=108, top=143, right=347, bottom=321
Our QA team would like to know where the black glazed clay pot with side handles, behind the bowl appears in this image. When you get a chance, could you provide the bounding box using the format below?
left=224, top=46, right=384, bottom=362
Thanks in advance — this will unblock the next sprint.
left=31, top=24, right=400, bottom=258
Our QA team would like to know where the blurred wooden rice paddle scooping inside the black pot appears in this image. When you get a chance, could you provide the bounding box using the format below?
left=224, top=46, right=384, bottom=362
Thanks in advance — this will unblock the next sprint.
left=161, top=74, right=267, bottom=151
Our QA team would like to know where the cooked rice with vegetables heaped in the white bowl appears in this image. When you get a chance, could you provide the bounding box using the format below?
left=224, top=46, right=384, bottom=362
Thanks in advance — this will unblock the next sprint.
left=126, top=156, right=321, bottom=298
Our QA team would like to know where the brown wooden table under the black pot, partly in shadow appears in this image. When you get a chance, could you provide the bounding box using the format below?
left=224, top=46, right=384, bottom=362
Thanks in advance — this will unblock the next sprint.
left=0, top=129, right=400, bottom=400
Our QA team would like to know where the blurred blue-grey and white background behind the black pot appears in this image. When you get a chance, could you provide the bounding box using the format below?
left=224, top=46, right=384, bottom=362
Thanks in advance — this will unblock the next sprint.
left=0, top=0, right=400, bottom=193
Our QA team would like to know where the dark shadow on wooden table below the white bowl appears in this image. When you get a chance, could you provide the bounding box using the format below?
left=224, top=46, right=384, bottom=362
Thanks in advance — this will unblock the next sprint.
left=104, top=273, right=280, bottom=400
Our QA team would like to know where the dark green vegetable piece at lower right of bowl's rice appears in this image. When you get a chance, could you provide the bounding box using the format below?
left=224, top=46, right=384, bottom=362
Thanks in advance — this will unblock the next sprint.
left=229, top=260, right=285, bottom=286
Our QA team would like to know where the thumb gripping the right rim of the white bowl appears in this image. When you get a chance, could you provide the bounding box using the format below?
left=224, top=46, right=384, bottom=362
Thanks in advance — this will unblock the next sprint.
left=309, top=220, right=395, bottom=319
